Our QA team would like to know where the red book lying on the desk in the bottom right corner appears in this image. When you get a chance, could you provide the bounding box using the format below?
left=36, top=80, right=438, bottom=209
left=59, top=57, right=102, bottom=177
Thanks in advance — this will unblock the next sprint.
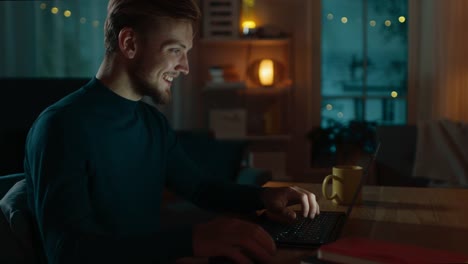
left=310, top=237, right=468, bottom=264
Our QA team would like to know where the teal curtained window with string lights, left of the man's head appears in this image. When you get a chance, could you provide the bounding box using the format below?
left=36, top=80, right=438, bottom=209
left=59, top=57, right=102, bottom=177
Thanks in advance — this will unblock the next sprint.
left=0, top=0, right=107, bottom=78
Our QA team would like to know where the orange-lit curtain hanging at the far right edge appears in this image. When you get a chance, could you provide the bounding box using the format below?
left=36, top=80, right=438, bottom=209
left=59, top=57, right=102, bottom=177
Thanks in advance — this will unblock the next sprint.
left=410, top=0, right=468, bottom=122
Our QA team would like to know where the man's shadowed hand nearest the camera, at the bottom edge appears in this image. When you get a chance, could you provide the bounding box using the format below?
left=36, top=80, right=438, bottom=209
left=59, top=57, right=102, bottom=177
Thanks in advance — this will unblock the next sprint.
left=193, top=217, right=276, bottom=263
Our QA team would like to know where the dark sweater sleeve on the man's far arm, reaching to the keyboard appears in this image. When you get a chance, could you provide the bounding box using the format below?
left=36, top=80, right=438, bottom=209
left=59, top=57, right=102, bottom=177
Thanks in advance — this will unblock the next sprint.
left=167, top=125, right=264, bottom=213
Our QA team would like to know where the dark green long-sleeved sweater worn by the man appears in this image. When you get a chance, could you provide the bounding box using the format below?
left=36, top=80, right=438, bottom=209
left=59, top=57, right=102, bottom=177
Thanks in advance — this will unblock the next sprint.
left=25, top=78, right=261, bottom=263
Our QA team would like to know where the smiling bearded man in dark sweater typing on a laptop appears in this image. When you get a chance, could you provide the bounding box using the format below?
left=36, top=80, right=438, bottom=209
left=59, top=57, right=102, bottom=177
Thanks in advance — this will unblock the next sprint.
left=24, top=0, right=319, bottom=263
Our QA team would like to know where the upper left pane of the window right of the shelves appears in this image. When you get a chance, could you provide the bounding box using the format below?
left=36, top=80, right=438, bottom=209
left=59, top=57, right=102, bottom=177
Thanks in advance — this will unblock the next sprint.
left=322, top=0, right=364, bottom=96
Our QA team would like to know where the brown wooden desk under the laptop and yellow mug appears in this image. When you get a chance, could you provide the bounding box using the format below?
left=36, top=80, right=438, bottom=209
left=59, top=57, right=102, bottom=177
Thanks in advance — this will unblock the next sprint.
left=266, top=182, right=468, bottom=264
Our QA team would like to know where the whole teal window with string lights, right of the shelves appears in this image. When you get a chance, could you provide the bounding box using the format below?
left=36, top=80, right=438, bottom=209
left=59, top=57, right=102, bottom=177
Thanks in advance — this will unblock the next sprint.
left=321, top=0, right=408, bottom=127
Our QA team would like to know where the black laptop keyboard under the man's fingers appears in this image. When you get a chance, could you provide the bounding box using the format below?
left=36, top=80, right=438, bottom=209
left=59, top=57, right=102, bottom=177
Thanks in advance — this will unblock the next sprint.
left=262, top=211, right=344, bottom=245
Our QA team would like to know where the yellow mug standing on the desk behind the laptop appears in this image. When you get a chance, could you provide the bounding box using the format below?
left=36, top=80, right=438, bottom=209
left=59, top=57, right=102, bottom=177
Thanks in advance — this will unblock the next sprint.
left=322, top=165, right=362, bottom=205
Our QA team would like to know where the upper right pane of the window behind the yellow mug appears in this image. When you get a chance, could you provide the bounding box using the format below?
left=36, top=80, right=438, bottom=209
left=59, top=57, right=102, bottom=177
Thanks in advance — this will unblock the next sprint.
left=367, top=0, right=408, bottom=98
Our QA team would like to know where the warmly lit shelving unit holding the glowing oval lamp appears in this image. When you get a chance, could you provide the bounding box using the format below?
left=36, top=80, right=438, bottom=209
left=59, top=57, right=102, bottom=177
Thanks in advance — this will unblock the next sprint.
left=198, top=36, right=294, bottom=177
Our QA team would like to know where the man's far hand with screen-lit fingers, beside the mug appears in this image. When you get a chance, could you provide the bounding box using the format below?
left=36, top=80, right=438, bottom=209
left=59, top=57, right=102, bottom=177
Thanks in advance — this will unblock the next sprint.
left=261, top=186, right=320, bottom=221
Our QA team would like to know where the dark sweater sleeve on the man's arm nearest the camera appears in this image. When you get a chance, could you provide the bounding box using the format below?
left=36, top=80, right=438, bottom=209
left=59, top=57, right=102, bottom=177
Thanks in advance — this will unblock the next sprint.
left=25, top=112, right=192, bottom=263
